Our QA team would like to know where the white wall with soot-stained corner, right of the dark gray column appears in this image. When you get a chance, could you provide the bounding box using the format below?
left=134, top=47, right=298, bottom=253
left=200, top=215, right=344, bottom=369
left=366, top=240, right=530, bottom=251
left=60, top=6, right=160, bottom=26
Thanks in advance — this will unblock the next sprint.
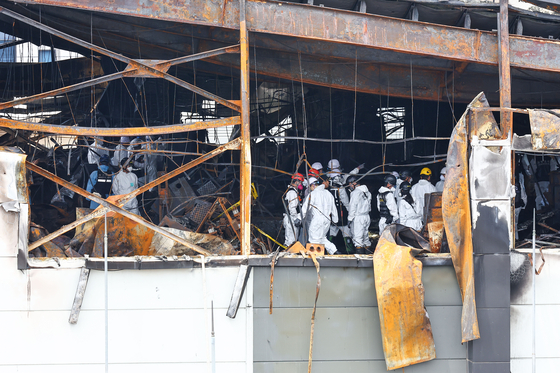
left=511, top=250, right=560, bottom=373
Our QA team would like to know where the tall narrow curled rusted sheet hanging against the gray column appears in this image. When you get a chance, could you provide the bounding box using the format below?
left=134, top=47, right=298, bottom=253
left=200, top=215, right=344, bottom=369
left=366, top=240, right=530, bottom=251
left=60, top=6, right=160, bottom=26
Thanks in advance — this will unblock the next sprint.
left=442, top=93, right=487, bottom=342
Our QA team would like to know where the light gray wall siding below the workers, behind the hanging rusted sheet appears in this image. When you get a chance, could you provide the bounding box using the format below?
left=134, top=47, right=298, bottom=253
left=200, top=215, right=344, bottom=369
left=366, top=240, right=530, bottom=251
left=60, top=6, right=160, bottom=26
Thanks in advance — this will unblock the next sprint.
left=253, top=266, right=467, bottom=373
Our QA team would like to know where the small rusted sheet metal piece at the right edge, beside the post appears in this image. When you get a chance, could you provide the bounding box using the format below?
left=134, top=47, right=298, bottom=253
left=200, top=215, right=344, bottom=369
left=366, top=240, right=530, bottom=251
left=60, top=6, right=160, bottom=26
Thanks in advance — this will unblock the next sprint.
left=529, top=110, right=560, bottom=150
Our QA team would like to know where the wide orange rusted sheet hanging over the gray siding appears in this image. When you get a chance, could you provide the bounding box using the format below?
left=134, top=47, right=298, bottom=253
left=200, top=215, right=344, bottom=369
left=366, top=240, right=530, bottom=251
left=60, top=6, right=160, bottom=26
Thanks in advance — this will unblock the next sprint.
left=373, top=224, right=436, bottom=370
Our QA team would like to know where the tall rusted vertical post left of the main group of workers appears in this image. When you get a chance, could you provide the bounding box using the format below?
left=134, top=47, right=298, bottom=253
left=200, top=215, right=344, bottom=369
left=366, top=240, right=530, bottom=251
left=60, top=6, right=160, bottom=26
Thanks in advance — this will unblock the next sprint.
left=239, top=0, right=251, bottom=255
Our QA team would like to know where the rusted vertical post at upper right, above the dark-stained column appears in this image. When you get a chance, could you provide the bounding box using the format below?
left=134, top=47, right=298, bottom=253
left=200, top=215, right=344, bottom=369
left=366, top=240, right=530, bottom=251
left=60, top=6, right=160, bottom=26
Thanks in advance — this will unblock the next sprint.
left=498, top=0, right=513, bottom=139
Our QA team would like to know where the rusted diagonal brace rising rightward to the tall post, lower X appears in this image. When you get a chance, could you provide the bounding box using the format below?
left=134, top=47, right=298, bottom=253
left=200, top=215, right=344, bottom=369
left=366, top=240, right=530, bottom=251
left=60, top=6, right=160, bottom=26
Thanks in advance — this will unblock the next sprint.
left=28, top=138, right=241, bottom=251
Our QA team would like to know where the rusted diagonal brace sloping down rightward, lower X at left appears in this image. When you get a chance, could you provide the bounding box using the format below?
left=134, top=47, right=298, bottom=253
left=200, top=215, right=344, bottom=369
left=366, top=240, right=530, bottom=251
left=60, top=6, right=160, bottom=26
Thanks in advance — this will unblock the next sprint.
left=26, top=162, right=210, bottom=255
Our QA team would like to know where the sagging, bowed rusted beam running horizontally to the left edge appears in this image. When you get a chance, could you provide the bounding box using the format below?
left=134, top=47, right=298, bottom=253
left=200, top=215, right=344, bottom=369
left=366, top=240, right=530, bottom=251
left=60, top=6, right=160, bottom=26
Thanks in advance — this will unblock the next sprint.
left=0, top=117, right=241, bottom=137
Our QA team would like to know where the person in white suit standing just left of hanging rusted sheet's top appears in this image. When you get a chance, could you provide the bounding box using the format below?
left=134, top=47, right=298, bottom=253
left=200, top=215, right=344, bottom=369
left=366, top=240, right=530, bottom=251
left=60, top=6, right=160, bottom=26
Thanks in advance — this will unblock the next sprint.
left=347, top=175, right=371, bottom=254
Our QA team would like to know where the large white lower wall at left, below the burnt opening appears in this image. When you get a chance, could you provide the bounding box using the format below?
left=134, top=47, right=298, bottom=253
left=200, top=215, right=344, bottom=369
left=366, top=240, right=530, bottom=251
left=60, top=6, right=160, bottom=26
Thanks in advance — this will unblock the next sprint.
left=0, top=208, right=253, bottom=373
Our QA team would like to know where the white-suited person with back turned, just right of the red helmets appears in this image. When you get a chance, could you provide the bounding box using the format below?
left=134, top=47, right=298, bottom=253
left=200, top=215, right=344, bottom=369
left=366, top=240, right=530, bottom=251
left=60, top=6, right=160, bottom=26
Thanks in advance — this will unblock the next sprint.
left=302, top=177, right=338, bottom=255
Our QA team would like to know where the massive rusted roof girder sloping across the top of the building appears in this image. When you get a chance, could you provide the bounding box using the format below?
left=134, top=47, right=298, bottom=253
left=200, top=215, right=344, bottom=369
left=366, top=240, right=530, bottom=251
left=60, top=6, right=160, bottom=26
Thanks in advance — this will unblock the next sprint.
left=16, top=0, right=560, bottom=71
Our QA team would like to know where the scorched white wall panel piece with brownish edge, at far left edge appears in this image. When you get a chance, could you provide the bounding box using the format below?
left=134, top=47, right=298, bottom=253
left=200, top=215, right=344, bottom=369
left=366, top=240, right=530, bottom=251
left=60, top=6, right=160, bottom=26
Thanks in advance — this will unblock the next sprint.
left=0, top=147, right=29, bottom=203
